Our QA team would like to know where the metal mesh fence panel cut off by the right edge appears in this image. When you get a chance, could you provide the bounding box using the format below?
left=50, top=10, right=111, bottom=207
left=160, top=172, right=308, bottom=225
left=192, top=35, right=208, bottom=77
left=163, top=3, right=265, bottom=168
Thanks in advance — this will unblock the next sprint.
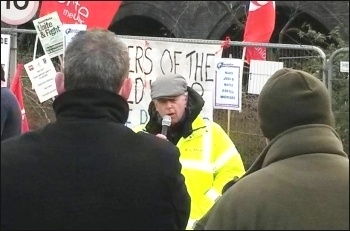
left=327, top=47, right=349, bottom=155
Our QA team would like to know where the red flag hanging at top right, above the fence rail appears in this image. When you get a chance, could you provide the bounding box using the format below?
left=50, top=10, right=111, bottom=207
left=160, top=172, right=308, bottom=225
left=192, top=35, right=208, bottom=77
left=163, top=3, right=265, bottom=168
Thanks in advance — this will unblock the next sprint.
left=243, top=1, right=276, bottom=63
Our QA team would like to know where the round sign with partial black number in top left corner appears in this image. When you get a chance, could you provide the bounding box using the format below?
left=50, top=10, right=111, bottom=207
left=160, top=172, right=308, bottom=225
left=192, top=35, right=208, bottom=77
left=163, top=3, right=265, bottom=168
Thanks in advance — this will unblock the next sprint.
left=1, top=1, right=39, bottom=25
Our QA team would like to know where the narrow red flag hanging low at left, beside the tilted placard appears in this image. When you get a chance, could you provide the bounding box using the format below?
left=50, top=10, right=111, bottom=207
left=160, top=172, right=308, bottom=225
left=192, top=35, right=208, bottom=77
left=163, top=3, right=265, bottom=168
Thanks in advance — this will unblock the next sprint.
left=10, top=64, right=29, bottom=133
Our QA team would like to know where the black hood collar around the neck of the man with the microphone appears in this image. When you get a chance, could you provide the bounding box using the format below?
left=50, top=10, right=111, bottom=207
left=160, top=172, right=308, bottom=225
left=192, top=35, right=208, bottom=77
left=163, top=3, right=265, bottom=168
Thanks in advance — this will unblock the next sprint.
left=145, top=87, right=204, bottom=138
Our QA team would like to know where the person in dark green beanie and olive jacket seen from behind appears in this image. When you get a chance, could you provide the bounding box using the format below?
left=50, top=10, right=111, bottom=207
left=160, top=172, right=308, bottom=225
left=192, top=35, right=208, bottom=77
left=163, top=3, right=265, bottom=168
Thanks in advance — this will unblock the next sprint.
left=195, top=68, right=349, bottom=230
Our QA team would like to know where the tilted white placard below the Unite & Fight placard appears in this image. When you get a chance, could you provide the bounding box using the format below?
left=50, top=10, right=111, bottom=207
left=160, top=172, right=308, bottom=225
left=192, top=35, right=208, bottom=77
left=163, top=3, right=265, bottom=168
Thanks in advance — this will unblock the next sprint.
left=24, top=55, right=58, bottom=103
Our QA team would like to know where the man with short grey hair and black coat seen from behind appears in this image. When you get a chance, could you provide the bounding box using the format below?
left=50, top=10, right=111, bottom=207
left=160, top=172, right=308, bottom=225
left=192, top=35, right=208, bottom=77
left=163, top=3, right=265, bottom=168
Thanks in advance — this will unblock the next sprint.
left=1, top=29, right=190, bottom=230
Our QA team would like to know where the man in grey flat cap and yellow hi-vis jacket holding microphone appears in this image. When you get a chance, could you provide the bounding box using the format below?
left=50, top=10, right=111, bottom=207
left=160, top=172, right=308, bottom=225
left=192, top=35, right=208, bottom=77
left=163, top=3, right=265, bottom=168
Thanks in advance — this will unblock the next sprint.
left=134, top=74, right=245, bottom=229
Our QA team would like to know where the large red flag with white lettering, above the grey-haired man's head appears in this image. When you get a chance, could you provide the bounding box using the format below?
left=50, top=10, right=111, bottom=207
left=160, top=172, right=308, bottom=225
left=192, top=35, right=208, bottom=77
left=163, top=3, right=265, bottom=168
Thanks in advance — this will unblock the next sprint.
left=39, top=1, right=122, bottom=29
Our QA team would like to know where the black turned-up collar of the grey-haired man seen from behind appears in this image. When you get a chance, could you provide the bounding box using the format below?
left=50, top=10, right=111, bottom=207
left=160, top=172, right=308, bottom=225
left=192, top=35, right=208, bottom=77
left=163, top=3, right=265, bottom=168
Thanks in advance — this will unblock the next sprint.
left=53, top=89, right=129, bottom=124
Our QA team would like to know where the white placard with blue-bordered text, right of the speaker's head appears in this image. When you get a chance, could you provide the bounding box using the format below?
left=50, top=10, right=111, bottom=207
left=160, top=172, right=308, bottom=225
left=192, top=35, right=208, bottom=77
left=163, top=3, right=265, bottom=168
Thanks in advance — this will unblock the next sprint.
left=213, top=58, right=243, bottom=111
